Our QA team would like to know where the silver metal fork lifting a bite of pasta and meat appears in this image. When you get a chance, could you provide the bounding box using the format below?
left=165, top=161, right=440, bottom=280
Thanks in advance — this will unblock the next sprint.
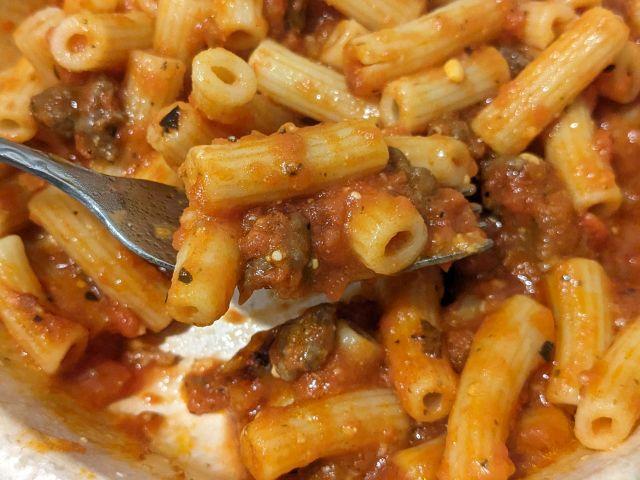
left=0, top=139, right=493, bottom=271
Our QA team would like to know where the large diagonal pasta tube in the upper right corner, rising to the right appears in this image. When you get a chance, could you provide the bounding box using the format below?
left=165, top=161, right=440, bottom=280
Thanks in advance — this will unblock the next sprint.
left=472, top=7, right=629, bottom=154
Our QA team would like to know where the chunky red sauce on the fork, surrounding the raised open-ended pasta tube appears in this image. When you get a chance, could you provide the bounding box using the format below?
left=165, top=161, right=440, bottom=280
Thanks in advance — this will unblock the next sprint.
left=240, top=165, right=484, bottom=300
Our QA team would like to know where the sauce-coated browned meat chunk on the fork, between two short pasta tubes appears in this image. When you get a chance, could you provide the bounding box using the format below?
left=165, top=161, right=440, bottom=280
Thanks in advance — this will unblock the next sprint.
left=239, top=211, right=311, bottom=298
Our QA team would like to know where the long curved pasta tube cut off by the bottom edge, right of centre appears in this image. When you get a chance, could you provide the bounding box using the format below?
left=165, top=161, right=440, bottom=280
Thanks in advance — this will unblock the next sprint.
left=438, top=295, right=553, bottom=480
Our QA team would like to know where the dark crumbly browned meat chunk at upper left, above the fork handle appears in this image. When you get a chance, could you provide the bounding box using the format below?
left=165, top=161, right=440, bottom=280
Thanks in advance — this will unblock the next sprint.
left=31, top=75, right=125, bottom=161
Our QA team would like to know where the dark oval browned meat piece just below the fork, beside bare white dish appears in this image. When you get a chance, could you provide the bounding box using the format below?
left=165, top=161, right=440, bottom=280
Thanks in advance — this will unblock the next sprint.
left=269, top=303, right=336, bottom=381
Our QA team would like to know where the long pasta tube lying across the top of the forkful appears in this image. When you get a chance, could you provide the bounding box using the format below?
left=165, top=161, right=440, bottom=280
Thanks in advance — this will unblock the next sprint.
left=180, top=120, right=389, bottom=212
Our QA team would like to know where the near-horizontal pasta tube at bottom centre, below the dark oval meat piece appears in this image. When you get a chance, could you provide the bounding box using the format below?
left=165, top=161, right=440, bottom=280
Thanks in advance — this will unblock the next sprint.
left=240, top=389, right=410, bottom=480
